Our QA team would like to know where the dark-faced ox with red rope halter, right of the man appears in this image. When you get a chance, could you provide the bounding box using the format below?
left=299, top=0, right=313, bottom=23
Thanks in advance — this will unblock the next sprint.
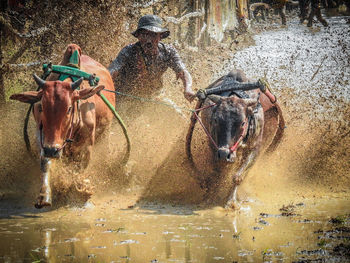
left=187, top=70, right=284, bottom=207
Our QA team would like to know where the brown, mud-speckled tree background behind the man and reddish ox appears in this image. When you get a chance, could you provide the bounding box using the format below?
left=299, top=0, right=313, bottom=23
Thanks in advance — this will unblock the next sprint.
left=0, top=0, right=246, bottom=103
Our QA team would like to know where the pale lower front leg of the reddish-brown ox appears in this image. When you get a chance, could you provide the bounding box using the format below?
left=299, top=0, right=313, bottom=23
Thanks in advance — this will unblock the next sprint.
left=35, top=157, right=52, bottom=209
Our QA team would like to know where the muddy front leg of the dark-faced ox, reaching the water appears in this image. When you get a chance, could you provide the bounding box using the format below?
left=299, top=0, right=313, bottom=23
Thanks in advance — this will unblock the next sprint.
left=225, top=150, right=258, bottom=209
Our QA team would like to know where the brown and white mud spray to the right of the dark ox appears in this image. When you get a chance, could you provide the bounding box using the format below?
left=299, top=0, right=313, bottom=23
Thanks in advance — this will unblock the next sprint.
left=230, top=17, right=350, bottom=208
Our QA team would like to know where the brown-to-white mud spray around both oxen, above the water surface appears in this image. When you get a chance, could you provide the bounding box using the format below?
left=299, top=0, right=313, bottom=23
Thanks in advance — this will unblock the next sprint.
left=0, top=17, right=350, bottom=210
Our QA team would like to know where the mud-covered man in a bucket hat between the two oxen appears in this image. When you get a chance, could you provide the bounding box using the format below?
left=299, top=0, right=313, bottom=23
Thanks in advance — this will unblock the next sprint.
left=108, top=15, right=195, bottom=101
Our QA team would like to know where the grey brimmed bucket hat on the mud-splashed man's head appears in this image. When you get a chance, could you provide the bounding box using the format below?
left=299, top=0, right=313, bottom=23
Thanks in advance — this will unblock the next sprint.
left=131, top=15, right=170, bottom=39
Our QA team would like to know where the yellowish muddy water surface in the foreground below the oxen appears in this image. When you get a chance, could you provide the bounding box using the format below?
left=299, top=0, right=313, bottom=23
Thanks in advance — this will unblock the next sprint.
left=0, top=200, right=350, bottom=262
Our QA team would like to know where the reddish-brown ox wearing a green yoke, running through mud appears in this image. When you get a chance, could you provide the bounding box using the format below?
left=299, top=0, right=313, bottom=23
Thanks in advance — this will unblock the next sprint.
left=10, top=44, right=115, bottom=208
